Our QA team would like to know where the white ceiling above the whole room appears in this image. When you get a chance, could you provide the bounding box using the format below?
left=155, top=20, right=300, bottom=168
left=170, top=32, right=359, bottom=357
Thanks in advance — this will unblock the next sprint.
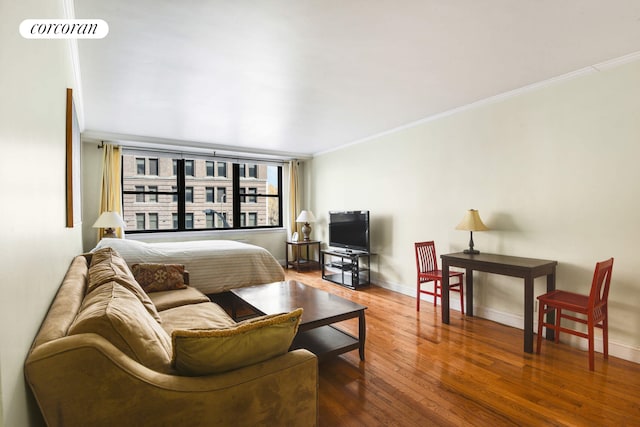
left=75, top=0, right=640, bottom=157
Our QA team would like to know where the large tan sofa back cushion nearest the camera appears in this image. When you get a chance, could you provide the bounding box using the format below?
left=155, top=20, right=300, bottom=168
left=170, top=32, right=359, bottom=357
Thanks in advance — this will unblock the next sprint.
left=69, top=281, right=171, bottom=372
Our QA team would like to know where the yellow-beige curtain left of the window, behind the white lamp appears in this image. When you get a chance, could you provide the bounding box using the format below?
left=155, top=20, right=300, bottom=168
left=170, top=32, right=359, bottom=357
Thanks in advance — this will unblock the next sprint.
left=98, top=144, right=124, bottom=240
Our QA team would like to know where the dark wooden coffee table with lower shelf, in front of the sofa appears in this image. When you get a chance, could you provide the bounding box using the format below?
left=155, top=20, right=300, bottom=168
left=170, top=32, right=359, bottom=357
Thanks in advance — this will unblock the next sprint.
left=231, top=280, right=367, bottom=360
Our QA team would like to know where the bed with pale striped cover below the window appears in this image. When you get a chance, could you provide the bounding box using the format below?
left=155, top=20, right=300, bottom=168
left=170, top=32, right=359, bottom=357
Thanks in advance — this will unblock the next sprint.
left=93, top=238, right=284, bottom=294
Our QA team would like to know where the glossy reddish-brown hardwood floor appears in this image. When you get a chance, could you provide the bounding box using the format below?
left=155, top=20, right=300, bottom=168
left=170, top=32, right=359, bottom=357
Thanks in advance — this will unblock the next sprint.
left=286, top=270, right=640, bottom=427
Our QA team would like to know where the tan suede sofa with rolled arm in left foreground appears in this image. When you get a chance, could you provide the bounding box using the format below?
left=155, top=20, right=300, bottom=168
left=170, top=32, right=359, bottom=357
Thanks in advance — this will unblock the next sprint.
left=25, top=249, right=318, bottom=426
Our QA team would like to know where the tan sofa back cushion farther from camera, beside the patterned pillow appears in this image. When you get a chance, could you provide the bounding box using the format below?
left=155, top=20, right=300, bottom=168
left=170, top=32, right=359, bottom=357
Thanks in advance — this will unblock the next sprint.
left=87, top=248, right=161, bottom=322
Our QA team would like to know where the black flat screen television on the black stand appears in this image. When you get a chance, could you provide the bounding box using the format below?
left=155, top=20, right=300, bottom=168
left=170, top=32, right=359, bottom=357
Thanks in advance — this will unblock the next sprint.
left=329, top=211, right=369, bottom=252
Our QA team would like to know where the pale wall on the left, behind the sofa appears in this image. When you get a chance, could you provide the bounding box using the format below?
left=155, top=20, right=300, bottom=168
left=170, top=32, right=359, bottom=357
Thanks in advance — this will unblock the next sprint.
left=0, top=0, right=81, bottom=426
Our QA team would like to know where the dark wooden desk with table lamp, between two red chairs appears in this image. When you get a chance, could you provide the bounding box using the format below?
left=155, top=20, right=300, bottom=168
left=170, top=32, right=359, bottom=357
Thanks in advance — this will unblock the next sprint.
left=440, top=252, right=558, bottom=353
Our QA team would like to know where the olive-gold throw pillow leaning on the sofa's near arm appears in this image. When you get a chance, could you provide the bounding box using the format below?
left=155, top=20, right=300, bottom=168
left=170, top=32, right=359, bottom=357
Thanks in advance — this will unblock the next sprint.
left=171, top=308, right=302, bottom=375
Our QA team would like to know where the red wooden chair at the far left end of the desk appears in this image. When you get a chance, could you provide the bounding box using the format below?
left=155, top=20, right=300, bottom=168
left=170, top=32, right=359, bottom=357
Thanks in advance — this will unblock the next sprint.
left=415, top=241, right=464, bottom=314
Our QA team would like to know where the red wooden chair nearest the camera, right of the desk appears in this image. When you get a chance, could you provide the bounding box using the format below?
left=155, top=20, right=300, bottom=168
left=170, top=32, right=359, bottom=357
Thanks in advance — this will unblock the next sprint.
left=536, top=258, right=613, bottom=371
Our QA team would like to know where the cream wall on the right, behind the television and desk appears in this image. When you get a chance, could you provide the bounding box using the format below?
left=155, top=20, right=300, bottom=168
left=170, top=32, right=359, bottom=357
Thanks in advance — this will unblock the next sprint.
left=307, top=61, right=640, bottom=362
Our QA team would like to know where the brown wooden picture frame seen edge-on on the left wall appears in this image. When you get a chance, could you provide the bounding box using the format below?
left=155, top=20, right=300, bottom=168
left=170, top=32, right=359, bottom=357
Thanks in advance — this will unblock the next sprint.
left=66, top=88, right=82, bottom=228
